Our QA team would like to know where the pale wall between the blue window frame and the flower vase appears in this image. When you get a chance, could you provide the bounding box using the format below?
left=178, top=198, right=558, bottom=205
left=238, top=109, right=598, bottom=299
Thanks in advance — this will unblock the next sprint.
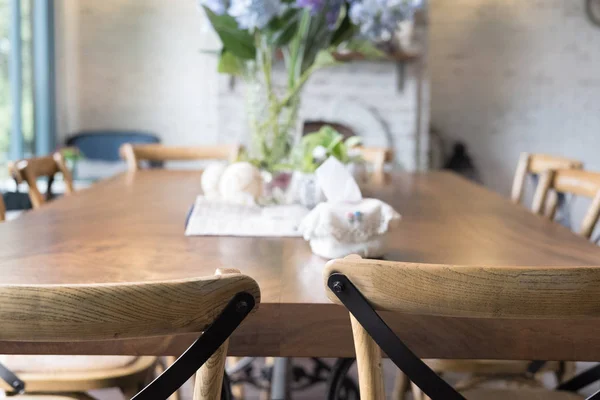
left=56, top=0, right=218, bottom=145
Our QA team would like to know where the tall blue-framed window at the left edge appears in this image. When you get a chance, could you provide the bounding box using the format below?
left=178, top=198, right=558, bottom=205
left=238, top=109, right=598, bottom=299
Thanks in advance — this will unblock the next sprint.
left=0, top=0, right=54, bottom=165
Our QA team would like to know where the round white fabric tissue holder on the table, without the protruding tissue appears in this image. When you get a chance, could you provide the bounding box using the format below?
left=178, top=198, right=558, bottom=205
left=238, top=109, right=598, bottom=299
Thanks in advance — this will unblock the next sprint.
left=300, top=199, right=401, bottom=258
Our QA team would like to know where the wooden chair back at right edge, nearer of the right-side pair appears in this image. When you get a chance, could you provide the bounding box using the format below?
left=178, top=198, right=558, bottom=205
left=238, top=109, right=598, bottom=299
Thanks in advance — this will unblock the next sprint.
left=533, top=169, right=600, bottom=239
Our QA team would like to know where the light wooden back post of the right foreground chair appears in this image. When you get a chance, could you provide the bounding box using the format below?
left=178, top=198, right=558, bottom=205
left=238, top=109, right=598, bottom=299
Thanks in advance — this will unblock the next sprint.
left=350, top=314, right=385, bottom=400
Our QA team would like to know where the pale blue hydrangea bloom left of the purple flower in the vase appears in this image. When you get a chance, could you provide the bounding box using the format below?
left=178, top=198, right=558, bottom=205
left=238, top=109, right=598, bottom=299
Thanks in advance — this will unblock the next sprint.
left=228, top=0, right=285, bottom=30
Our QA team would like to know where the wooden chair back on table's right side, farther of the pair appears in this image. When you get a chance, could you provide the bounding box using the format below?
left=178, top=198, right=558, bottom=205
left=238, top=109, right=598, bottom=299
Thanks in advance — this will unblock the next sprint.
left=511, top=153, right=583, bottom=204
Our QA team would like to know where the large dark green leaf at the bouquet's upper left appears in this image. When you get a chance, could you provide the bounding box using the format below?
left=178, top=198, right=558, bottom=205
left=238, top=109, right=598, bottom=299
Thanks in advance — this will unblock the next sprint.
left=204, top=7, right=256, bottom=60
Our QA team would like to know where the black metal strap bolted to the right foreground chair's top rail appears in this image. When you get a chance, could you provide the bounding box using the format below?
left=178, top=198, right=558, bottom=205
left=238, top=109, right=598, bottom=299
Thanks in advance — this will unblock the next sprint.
left=327, top=273, right=465, bottom=400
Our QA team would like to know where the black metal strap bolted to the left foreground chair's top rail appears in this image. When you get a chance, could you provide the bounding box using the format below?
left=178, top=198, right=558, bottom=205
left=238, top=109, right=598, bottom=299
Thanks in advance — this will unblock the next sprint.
left=131, top=292, right=255, bottom=400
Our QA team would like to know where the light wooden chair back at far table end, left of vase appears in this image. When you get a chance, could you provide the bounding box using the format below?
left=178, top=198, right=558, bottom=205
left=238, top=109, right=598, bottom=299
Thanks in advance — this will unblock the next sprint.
left=120, top=143, right=240, bottom=171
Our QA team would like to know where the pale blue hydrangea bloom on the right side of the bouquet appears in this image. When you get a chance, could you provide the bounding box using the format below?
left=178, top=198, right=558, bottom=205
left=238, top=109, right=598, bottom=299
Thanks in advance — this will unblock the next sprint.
left=349, top=0, right=422, bottom=41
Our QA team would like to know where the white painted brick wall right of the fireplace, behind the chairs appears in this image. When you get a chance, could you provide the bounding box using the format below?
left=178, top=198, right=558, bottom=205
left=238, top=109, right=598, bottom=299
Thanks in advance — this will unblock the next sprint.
left=429, top=0, right=600, bottom=209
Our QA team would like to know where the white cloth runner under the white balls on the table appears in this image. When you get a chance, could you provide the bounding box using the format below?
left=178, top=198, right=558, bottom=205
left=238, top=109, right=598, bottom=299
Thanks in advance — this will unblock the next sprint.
left=185, top=196, right=308, bottom=237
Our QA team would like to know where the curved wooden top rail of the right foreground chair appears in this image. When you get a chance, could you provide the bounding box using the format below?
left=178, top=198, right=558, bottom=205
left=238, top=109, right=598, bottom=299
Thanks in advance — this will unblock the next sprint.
left=325, top=259, right=600, bottom=319
